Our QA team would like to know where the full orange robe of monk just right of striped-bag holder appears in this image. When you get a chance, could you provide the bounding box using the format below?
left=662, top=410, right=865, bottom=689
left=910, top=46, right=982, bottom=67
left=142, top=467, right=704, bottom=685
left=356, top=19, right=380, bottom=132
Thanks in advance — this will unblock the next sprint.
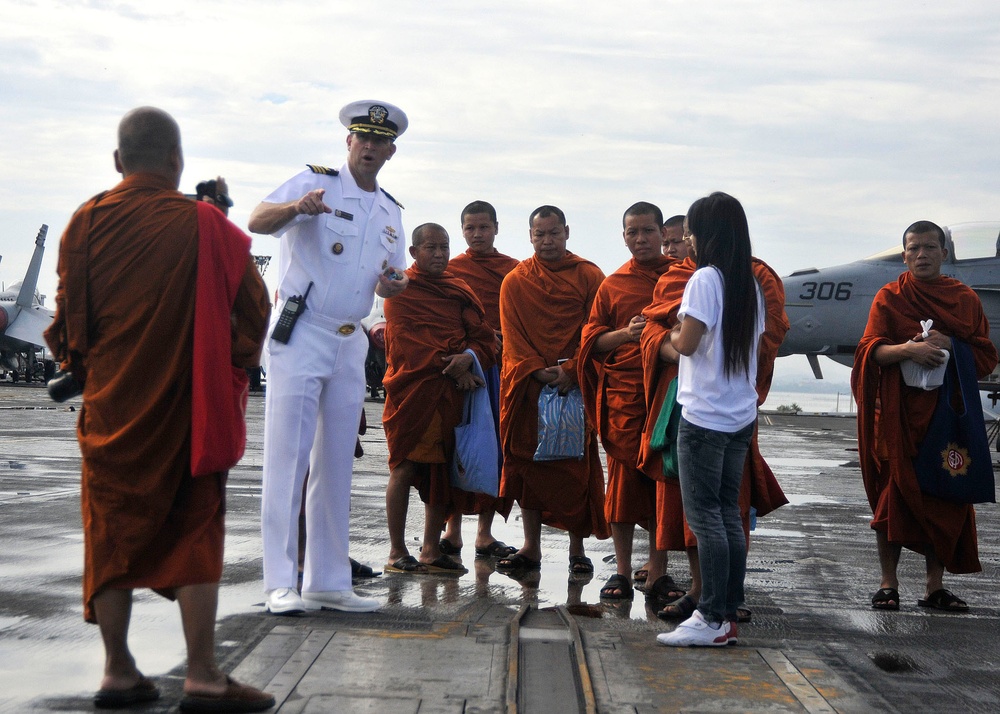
left=577, top=255, right=673, bottom=524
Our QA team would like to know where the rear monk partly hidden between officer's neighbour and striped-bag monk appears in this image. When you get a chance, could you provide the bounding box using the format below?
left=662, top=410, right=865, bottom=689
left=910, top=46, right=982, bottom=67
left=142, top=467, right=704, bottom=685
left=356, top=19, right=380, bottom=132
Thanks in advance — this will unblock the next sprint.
left=441, top=201, right=520, bottom=558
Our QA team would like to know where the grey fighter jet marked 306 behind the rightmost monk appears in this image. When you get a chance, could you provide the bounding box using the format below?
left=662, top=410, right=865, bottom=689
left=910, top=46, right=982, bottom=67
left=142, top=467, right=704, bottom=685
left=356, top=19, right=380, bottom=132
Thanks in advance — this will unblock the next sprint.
left=778, top=222, right=1000, bottom=379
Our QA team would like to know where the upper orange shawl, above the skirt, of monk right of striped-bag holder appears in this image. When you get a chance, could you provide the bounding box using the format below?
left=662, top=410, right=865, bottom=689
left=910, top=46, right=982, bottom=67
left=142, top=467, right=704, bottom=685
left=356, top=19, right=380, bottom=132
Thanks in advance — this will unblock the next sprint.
left=577, top=255, right=673, bottom=458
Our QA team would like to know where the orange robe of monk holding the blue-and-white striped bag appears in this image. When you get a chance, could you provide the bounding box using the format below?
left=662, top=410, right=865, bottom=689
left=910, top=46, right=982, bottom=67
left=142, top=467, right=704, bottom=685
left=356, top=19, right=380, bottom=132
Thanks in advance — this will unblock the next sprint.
left=500, top=252, right=610, bottom=538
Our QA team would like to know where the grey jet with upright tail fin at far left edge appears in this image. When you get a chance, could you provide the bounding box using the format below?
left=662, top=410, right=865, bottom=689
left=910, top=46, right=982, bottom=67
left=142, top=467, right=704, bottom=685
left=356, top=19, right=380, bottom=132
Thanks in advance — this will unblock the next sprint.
left=0, top=224, right=55, bottom=381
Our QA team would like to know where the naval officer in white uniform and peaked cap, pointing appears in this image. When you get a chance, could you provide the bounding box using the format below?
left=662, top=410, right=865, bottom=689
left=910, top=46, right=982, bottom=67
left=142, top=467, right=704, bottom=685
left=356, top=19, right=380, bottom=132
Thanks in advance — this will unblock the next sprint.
left=249, top=101, right=407, bottom=615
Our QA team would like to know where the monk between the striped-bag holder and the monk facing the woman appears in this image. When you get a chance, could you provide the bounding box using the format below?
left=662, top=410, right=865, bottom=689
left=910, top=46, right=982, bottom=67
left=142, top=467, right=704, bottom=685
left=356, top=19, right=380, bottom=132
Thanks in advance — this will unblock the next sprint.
left=579, top=202, right=673, bottom=600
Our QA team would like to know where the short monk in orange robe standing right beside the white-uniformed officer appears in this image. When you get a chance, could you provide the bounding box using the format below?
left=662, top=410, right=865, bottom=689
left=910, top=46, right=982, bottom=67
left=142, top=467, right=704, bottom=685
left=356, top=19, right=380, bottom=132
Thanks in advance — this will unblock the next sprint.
left=382, top=223, right=496, bottom=574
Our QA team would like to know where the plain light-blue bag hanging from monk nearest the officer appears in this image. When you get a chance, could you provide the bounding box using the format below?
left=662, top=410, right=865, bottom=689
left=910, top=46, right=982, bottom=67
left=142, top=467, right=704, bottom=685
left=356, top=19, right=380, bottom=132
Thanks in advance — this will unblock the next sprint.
left=451, top=350, right=500, bottom=496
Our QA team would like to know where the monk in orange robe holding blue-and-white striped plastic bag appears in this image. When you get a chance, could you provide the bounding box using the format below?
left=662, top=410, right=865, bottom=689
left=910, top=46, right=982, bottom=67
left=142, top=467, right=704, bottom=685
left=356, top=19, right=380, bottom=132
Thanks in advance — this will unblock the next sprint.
left=497, top=206, right=609, bottom=574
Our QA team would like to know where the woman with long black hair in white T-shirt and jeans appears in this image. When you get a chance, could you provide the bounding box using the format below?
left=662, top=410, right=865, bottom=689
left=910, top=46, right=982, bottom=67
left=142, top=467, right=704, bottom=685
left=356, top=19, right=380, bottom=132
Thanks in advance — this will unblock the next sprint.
left=657, top=192, right=765, bottom=646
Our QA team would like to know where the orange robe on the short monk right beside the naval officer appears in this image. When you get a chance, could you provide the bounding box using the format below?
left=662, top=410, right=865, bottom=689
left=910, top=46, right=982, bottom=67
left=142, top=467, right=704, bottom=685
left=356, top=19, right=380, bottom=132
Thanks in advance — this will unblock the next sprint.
left=382, top=265, right=496, bottom=506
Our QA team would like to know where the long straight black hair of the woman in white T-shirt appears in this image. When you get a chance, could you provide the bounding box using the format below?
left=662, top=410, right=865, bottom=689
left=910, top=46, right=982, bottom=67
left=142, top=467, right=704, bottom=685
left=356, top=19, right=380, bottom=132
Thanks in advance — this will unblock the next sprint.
left=687, top=191, right=757, bottom=376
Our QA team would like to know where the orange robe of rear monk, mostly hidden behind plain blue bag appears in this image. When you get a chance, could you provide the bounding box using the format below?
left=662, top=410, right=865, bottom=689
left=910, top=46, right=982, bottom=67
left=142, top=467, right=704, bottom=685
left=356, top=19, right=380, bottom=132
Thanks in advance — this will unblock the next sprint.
left=448, top=249, right=520, bottom=519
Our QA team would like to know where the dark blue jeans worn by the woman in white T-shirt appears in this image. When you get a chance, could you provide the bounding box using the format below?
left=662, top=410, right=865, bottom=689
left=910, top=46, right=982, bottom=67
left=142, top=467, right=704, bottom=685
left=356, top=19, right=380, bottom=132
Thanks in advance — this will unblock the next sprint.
left=677, top=417, right=756, bottom=622
